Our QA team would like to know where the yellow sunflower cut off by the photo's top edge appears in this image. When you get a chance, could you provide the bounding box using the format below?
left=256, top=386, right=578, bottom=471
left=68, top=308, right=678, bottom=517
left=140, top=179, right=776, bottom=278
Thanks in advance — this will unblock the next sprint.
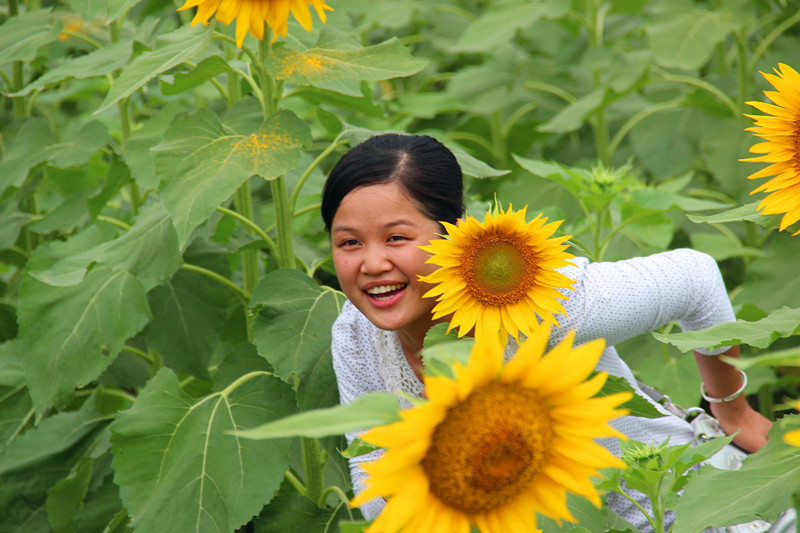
left=178, top=0, right=333, bottom=48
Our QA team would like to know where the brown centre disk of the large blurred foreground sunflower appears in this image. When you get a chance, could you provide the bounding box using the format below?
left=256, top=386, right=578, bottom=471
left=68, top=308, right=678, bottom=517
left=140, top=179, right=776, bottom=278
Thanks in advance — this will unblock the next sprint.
left=422, top=382, right=553, bottom=513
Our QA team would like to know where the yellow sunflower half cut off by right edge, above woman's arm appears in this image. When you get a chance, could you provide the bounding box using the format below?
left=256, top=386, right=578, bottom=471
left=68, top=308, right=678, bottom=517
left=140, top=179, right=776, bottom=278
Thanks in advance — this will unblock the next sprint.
left=741, top=64, right=800, bottom=235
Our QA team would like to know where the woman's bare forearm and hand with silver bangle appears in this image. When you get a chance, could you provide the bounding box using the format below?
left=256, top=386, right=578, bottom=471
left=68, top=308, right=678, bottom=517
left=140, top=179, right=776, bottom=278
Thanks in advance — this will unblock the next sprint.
left=694, top=346, right=772, bottom=453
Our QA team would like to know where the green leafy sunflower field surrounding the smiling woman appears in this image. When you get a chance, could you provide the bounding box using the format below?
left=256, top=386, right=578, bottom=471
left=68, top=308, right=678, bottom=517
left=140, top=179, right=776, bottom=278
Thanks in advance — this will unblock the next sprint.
left=0, top=0, right=800, bottom=533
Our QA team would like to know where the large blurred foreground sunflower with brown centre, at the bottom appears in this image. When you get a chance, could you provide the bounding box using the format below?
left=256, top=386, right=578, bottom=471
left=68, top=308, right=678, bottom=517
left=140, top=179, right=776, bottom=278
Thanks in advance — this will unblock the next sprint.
left=352, top=324, right=631, bottom=533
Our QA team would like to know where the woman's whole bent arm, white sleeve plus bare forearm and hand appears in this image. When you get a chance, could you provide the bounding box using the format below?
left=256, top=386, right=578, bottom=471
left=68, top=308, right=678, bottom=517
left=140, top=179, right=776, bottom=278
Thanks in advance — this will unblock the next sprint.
left=551, top=249, right=771, bottom=452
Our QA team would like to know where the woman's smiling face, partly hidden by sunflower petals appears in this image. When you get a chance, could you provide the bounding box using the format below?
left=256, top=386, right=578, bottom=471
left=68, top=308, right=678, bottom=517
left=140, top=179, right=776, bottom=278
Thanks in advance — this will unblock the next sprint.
left=331, top=183, right=442, bottom=339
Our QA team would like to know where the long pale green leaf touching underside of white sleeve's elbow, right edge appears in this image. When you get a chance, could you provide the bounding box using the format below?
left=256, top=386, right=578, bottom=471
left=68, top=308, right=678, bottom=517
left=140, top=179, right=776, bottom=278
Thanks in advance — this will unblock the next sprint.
left=651, top=307, right=800, bottom=352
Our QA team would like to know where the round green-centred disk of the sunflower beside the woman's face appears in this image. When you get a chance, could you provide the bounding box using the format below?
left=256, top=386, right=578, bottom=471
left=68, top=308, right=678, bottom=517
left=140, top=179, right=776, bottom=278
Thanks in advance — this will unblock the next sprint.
left=462, top=234, right=536, bottom=306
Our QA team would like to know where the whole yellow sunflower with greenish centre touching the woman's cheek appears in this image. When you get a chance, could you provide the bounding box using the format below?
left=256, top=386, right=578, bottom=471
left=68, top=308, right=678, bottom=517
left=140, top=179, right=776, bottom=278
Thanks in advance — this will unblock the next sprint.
left=420, top=205, right=574, bottom=339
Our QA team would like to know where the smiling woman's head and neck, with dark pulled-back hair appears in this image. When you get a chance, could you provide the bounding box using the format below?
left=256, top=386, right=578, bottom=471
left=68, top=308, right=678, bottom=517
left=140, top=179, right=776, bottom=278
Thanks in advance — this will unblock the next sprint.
left=322, top=134, right=464, bottom=378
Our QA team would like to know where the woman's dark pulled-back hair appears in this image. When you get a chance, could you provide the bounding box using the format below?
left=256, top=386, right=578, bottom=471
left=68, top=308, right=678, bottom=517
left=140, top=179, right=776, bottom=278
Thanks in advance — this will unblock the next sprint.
left=321, top=133, right=464, bottom=231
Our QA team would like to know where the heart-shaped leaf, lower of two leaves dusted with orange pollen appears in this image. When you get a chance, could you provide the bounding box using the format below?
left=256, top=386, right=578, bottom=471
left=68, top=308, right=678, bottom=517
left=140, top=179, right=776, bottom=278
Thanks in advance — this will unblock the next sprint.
left=153, top=109, right=311, bottom=247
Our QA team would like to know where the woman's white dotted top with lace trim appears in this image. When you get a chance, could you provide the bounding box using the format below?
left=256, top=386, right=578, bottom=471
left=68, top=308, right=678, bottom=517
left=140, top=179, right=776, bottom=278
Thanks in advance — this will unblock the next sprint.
left=332, top=249, right=735, bottom=530
